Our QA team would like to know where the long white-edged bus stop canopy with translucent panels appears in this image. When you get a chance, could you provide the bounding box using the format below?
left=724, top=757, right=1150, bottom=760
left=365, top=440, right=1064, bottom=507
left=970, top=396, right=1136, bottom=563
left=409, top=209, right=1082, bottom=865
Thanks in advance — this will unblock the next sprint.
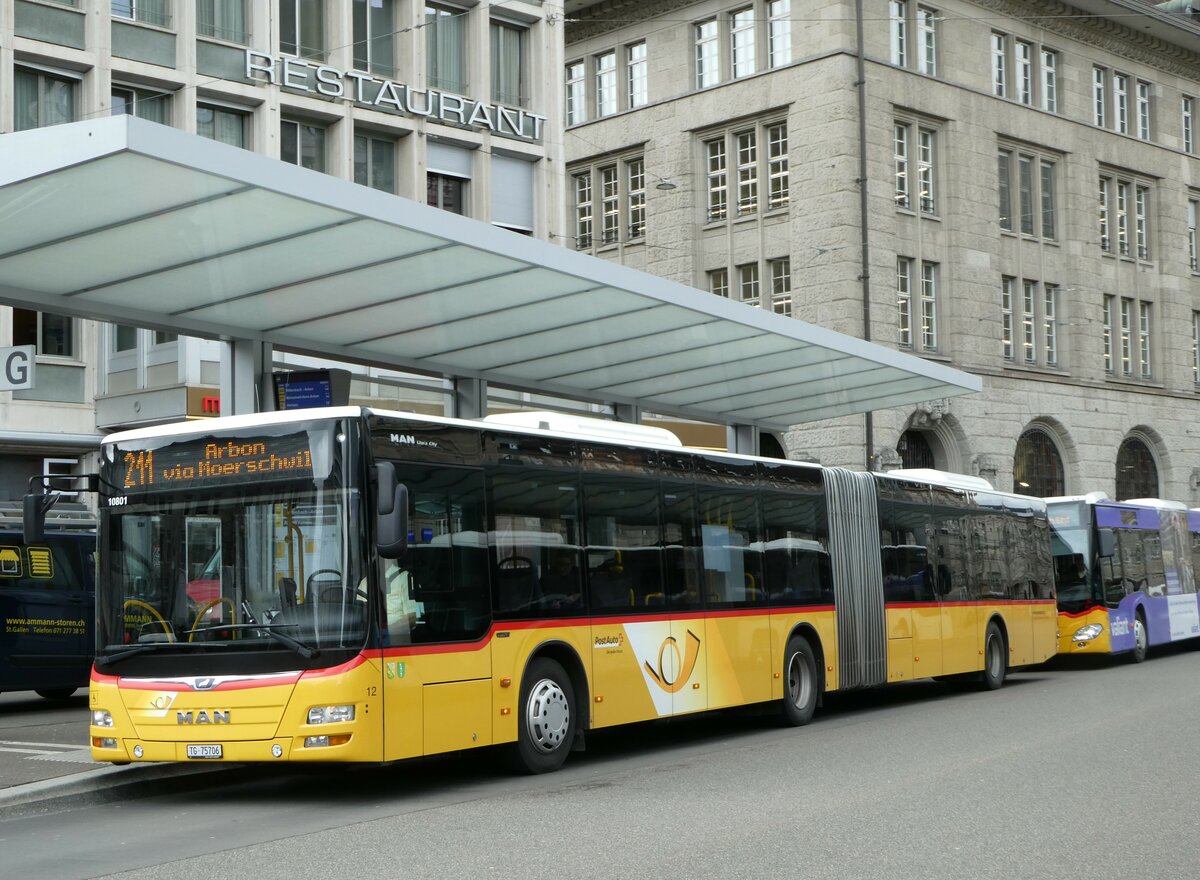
left=0, top=116, right=982, bottom=429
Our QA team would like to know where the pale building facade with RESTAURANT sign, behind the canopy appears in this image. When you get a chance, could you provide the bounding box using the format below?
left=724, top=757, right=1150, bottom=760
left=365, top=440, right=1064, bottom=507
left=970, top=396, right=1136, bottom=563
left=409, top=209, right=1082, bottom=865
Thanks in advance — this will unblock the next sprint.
left=0, top=0, right=565, bottom=498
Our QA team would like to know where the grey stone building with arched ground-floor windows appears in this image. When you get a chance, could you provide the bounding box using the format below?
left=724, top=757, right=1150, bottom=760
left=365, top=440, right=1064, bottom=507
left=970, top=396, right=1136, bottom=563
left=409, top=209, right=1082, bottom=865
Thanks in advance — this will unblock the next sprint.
left=562, top=0, right=1200, bottom=505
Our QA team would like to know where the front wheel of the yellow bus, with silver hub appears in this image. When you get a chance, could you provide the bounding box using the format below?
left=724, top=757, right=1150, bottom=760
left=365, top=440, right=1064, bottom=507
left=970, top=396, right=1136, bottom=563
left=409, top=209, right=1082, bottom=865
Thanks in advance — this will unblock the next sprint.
left=515, top=657, right=575, bottom=773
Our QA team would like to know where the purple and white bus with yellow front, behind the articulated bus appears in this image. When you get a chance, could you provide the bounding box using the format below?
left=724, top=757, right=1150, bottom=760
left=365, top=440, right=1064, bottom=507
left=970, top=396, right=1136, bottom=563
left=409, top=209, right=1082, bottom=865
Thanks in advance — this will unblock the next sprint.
left=1046, top=492, right=1200, bottom=663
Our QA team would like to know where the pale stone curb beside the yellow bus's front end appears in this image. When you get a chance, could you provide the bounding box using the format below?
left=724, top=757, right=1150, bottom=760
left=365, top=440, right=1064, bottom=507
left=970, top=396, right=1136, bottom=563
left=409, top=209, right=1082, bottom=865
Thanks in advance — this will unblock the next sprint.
left=0, top=764, right=242, bottom=820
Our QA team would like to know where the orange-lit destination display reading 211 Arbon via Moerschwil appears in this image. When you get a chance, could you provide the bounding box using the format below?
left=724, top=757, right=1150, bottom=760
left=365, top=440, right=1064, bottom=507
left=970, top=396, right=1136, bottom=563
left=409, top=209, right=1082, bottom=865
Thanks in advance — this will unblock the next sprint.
left=113, top=433, right=312, bottom=492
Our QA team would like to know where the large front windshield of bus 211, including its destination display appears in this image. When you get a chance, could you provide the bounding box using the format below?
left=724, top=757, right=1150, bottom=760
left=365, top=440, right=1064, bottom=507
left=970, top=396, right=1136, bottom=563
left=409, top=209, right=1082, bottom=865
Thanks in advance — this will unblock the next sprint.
left=97, top=425, right=368, bottom=672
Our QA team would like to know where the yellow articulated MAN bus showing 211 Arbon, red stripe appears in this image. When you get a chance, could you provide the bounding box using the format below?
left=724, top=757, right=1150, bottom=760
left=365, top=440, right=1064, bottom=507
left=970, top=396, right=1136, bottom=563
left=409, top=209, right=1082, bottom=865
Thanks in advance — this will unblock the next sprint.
left=82, top=407, right=1056, bottom=772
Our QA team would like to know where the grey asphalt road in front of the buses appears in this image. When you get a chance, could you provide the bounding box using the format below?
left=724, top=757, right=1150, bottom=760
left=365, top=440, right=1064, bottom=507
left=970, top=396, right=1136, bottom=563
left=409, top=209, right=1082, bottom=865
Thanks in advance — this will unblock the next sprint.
left=0, top=649, right=1200, bottom=880
